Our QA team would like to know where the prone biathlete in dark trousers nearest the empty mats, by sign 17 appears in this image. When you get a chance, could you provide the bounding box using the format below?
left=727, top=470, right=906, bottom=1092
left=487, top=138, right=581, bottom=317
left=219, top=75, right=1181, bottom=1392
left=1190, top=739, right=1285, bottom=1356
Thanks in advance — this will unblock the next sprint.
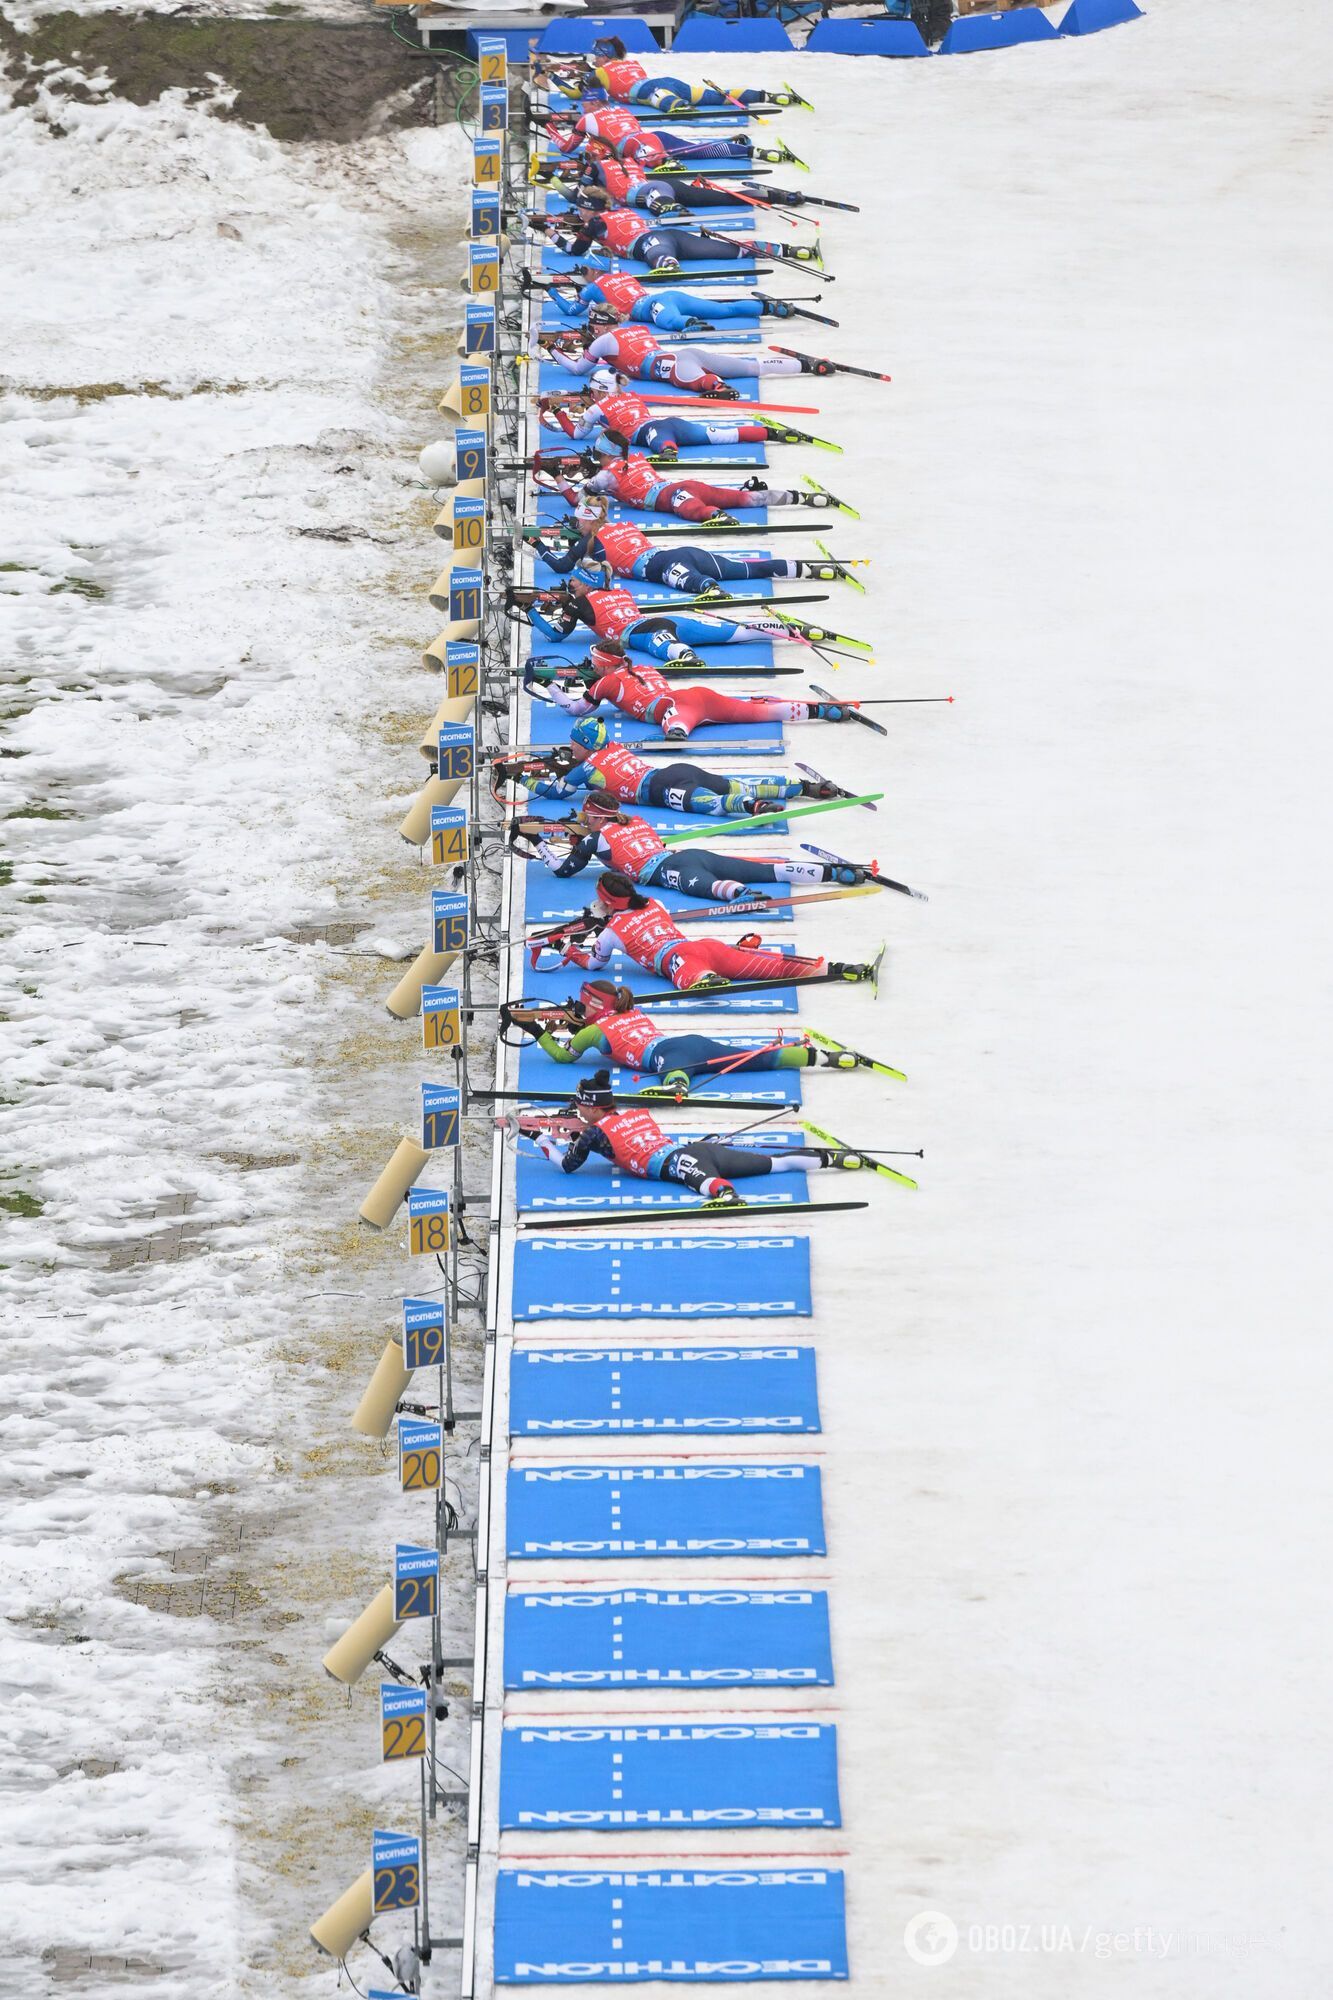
left=518, top=1070, right=856, bottom=1208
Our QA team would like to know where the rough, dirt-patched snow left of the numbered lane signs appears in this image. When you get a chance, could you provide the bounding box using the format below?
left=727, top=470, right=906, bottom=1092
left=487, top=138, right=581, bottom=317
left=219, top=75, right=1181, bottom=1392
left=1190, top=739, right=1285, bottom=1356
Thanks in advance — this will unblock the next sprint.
left=0, top=70, right=478, bottom=2000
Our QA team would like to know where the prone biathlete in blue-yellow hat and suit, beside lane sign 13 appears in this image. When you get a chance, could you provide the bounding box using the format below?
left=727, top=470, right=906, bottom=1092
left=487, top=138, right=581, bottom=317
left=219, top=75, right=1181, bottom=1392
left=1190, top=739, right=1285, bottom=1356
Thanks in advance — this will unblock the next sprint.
left=490, top=716, right=849, bottom=820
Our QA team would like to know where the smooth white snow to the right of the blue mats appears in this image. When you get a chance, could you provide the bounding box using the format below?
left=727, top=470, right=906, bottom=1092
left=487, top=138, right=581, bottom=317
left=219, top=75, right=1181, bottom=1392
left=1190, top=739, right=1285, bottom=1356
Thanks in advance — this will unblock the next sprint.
left=474, top=15, right=1333, bottom=2000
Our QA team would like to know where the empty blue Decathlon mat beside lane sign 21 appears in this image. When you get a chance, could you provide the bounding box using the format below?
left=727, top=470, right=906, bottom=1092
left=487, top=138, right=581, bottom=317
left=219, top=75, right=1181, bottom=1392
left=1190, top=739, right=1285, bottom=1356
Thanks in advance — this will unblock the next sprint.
left=504, top=1586, right=833, bottom=1694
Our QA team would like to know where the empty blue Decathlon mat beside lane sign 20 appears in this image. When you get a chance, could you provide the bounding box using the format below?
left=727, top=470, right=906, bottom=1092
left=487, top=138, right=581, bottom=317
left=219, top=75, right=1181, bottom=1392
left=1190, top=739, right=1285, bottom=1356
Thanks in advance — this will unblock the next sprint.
left=506, top=1458, right=827, bottom=1562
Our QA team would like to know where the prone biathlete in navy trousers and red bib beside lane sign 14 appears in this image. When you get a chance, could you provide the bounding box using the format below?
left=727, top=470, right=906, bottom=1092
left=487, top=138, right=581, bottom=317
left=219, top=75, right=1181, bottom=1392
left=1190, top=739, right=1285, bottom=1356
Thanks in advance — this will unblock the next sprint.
left=508, top=792, right=867, bottom=902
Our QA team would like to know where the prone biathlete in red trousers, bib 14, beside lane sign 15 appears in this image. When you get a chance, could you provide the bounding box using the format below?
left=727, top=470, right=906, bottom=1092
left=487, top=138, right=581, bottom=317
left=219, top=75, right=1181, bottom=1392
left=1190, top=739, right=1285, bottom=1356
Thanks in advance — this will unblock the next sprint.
left=528, top=868, right=879, bottom=994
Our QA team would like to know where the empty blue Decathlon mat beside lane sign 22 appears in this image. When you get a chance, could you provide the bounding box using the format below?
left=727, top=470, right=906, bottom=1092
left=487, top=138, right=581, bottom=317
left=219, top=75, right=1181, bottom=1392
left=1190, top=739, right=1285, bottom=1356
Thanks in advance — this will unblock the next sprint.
left=500, top=1718, right=843, bottom=1832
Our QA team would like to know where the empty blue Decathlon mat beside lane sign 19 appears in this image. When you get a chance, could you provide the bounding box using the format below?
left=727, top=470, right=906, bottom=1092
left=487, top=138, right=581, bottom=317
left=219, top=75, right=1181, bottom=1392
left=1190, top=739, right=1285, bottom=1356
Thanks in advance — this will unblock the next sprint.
left=508, top=1346, right=819, bottom=1438
